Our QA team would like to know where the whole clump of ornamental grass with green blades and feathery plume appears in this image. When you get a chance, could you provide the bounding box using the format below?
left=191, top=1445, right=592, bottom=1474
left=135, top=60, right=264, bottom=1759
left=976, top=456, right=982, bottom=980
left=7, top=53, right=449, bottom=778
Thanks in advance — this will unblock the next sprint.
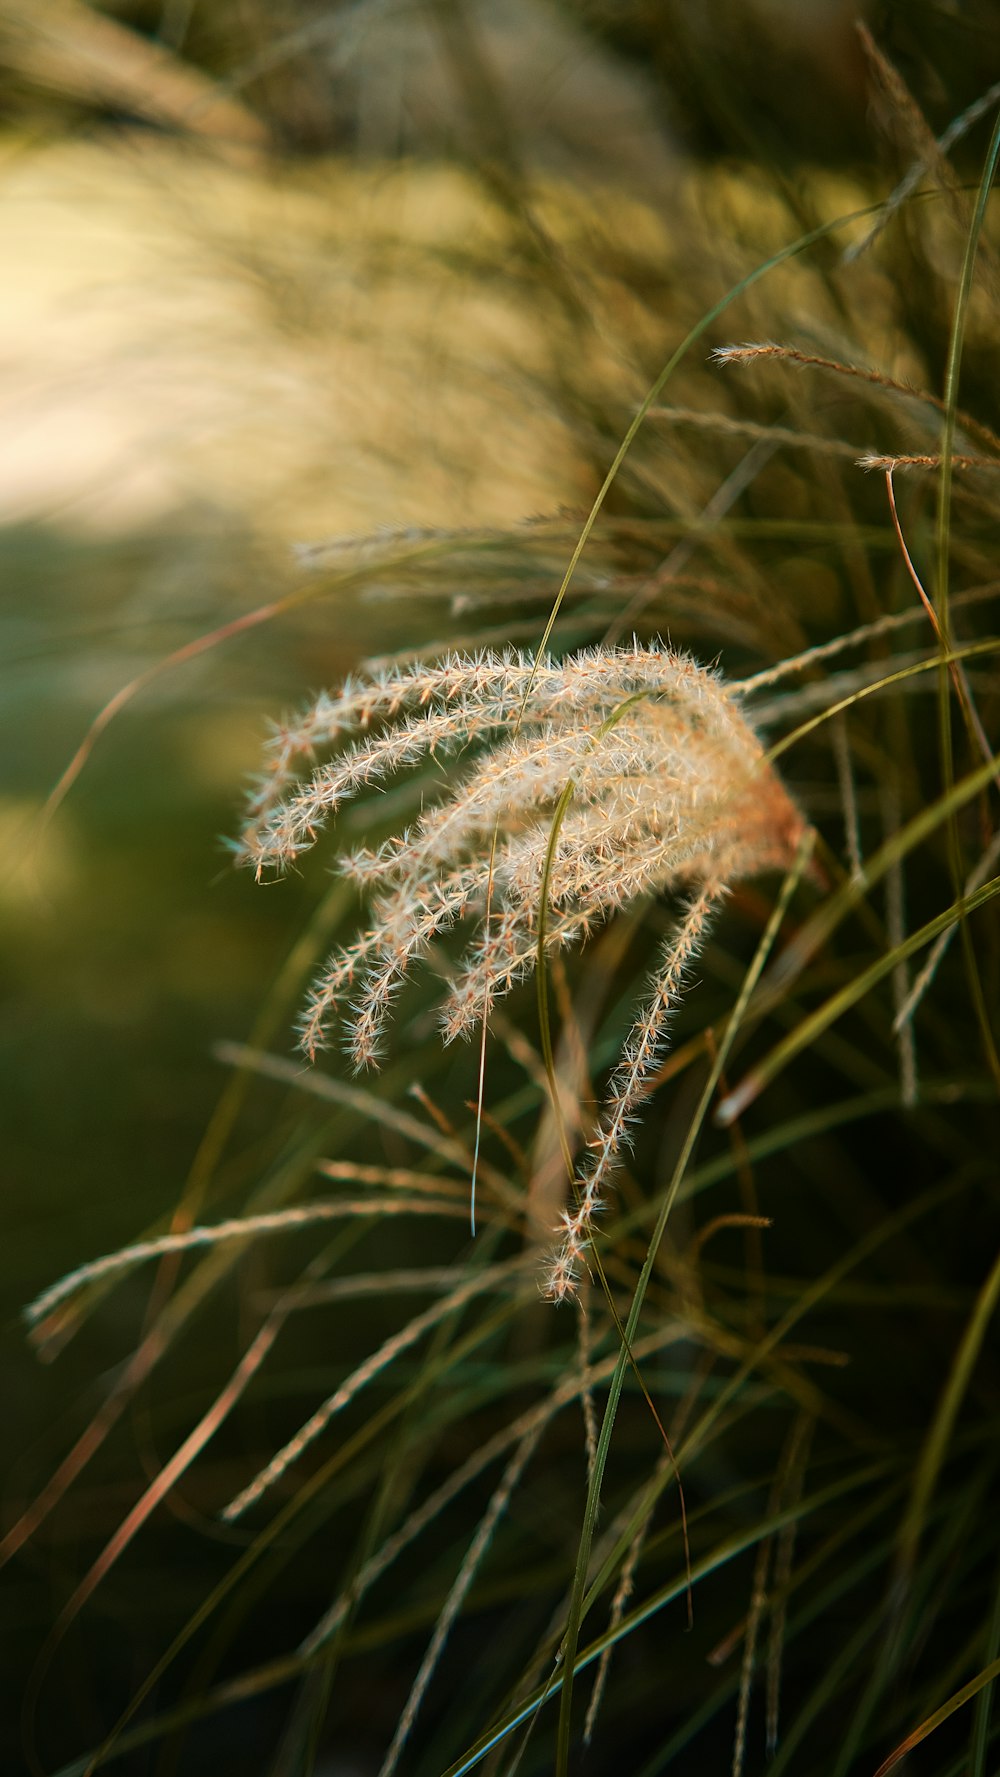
left=4, top=13, right=1000, bottom=1777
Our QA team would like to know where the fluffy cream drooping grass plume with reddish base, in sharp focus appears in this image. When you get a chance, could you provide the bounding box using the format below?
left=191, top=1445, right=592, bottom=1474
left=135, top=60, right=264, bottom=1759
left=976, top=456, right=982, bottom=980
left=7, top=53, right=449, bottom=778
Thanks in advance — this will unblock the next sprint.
left=240, top=641, right=803, bottom=1297
